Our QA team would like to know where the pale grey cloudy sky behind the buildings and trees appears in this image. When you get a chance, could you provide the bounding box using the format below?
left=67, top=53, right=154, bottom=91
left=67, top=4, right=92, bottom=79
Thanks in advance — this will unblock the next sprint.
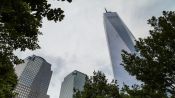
left=16, top=0, right=175, bottom=98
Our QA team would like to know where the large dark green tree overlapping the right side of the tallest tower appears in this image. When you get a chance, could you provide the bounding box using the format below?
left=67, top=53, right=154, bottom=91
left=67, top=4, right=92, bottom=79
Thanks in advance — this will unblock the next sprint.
left=122, top=11, right=175, bottom=98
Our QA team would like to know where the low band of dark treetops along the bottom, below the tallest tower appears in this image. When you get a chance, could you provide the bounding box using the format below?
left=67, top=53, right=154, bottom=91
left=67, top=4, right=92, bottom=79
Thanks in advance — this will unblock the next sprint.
left=74, top=71, right=167, bottom=98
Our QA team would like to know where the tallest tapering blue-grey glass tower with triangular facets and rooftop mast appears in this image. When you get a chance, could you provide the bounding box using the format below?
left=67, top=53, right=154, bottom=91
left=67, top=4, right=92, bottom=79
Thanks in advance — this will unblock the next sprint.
left=103, top=12, right=138, bottom=87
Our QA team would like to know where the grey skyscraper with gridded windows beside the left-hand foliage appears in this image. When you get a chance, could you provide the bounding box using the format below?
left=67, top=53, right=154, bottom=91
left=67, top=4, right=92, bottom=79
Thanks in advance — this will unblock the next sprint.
left=15, top=55, right=52, bottom=98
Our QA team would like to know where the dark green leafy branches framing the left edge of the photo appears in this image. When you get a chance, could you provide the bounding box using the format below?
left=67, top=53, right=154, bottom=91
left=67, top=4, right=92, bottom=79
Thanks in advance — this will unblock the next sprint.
left=0, top=0, right=71, bottom=98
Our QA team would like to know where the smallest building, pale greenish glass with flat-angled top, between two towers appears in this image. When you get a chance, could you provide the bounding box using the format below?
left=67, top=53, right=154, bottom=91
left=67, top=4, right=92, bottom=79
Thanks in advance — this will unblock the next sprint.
left=59, top=70, right=86, bottom=98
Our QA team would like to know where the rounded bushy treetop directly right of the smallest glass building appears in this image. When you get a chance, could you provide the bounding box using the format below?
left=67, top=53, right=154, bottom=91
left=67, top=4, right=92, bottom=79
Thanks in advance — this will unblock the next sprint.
left=74, top=71, right=119, bottom=98
